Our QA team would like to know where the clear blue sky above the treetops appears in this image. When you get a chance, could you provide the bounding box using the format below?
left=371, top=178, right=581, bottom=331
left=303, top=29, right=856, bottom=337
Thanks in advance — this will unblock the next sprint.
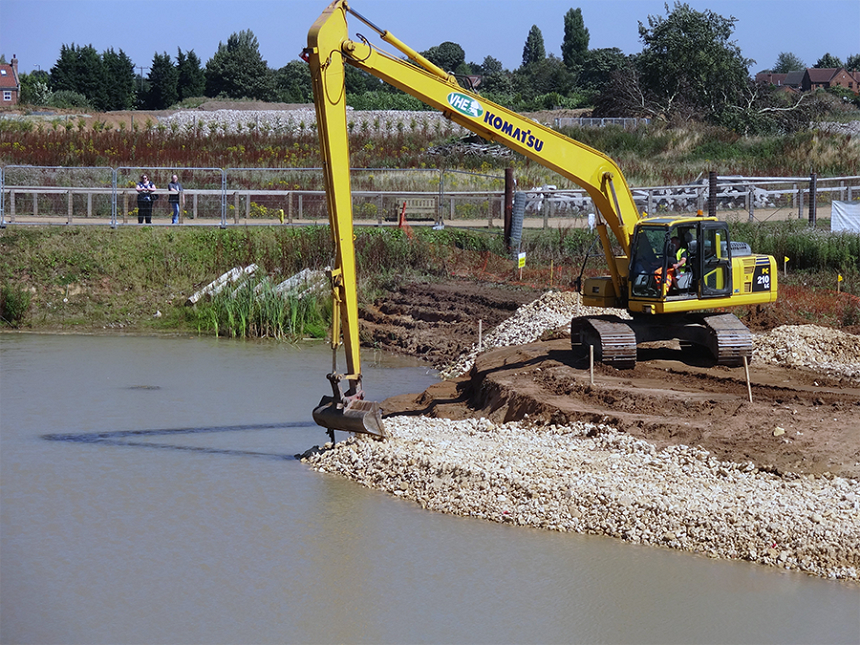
left=6, top=0, right=860, bottom=74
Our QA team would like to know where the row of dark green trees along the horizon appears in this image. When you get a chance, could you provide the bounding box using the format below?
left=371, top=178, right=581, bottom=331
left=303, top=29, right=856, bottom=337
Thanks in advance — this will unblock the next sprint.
left=11, top=2, right=860, bottom=133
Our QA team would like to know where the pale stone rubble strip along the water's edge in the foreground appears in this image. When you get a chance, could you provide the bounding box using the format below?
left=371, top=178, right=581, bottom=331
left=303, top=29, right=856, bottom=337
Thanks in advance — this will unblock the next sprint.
left=303, top=417, right=860, bottom=580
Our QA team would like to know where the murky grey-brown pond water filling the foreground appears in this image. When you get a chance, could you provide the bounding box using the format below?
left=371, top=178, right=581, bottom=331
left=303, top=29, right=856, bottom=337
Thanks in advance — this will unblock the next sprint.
left=0, top=335, right=860, bottom=645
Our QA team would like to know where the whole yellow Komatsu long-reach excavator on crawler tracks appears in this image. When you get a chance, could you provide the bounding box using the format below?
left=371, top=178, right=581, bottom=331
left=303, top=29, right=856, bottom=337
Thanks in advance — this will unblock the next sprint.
left=302, top=0, right=777, bottom=437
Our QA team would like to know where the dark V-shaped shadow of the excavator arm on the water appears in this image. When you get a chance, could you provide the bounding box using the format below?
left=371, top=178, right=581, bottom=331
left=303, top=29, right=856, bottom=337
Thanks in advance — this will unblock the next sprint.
left=41, top=421, right=315, bottom=460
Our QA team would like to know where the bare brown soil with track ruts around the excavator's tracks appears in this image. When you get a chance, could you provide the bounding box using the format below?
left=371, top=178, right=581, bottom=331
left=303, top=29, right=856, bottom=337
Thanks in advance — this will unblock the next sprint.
left=362, top=281, right=860, bottom=478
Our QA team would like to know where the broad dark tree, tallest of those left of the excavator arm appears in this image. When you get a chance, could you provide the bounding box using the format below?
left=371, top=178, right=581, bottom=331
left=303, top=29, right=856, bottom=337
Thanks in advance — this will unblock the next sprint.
left=206, top=29, right=274, bottom=101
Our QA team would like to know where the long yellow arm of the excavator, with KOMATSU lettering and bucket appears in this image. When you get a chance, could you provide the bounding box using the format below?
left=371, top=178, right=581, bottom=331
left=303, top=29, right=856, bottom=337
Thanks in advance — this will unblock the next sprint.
left=310, top=0, right=639, bottom=434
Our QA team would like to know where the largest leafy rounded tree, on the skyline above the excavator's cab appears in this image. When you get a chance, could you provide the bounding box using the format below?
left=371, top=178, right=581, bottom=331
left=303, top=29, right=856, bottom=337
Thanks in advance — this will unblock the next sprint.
left=636, top=2, right=754, bottom=119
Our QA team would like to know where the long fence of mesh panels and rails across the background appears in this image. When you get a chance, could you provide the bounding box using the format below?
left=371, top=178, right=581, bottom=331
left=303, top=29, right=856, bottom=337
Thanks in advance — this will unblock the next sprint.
left=0, top=166, right=860, bottom=228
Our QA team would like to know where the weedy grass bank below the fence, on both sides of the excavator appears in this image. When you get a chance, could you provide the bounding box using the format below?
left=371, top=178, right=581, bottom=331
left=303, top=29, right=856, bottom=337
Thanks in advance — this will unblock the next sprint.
left=0, top=222, right=860, bottom=339
